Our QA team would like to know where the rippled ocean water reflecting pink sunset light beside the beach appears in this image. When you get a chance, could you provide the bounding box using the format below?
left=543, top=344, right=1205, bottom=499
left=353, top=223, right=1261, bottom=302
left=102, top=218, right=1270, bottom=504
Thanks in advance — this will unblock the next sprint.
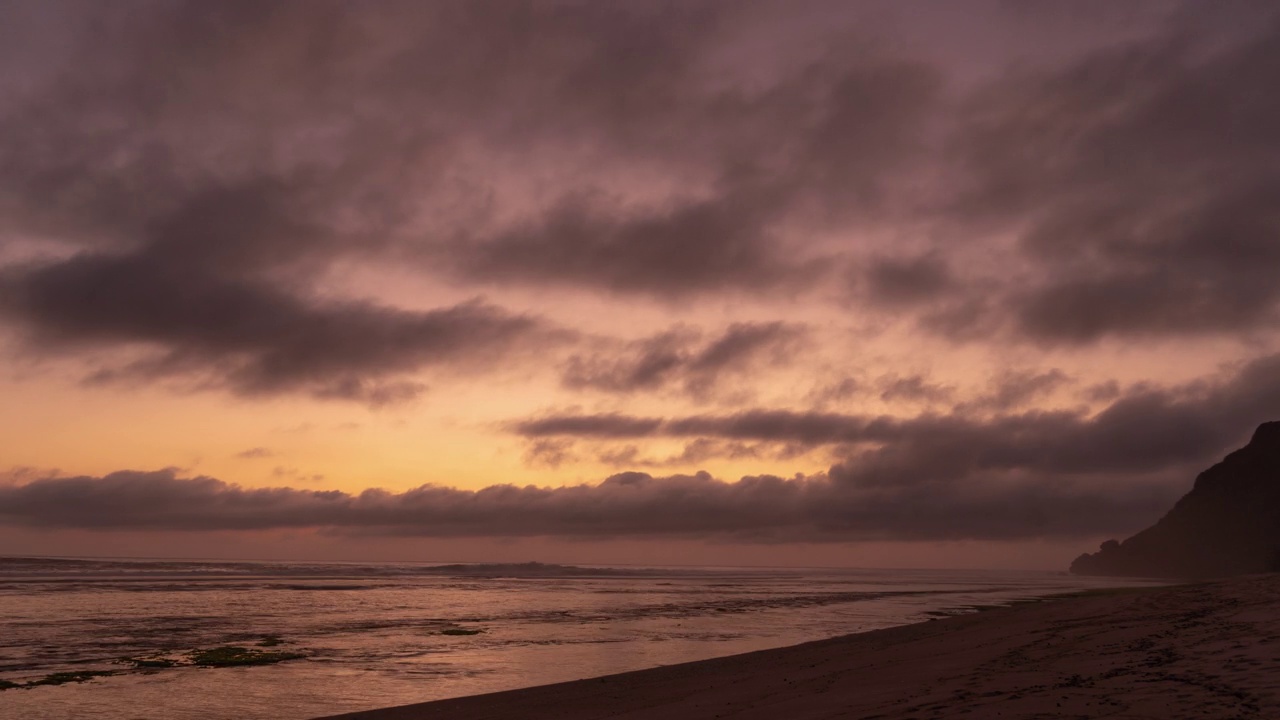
left=0, top=557, right=1152, bottom=720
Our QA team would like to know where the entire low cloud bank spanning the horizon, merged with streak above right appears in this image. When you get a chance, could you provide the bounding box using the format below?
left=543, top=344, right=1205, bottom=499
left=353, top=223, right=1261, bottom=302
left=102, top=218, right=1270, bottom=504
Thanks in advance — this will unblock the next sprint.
left=0, top=355, right=1280, bottom=542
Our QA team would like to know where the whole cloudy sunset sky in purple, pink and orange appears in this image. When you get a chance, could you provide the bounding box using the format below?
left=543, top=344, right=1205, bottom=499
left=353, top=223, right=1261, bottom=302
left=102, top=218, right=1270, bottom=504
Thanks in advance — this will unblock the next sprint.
left=0, top=0, right=1280, bottom=569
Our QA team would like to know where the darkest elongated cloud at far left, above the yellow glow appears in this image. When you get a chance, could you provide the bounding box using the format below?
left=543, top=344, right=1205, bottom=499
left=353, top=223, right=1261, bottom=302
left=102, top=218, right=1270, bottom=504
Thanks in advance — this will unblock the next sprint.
left=0, top=233, right=540, bottom=405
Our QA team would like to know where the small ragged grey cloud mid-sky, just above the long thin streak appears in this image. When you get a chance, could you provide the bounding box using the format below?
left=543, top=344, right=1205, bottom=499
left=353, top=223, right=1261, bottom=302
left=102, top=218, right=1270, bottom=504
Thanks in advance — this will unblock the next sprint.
left=562, top=323, right=806, bottom=400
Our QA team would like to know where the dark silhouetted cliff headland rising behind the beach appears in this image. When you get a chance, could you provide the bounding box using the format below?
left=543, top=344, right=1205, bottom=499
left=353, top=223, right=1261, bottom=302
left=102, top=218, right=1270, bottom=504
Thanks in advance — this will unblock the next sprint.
left=1071, top=423, right=1280, bottom=578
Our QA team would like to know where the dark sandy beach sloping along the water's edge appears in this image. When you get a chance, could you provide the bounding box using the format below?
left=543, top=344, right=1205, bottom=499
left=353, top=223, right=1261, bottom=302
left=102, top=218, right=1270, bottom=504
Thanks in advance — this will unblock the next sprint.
left=317, top=575, right=1280, bottom=720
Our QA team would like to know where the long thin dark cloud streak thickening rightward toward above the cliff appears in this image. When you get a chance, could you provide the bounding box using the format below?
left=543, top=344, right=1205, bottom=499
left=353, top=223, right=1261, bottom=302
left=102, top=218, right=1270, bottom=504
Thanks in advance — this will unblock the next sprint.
left=512, top=355, right=1280, bottom=474
